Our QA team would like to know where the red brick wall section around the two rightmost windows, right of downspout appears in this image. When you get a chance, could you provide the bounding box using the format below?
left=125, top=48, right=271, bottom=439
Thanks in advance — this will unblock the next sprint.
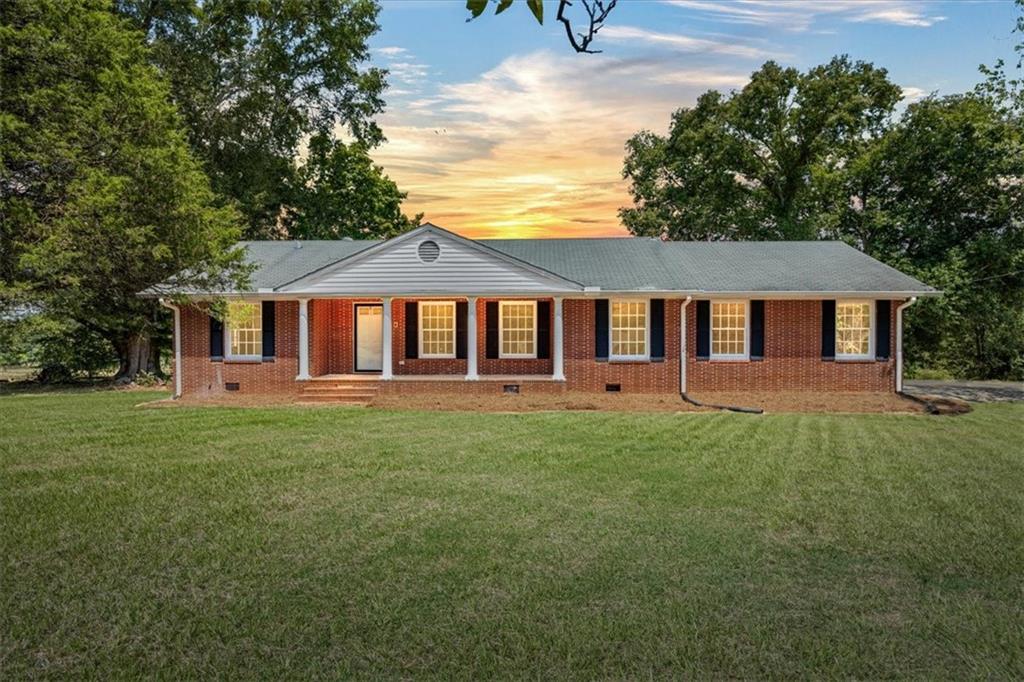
left=688, top=300, right=902, bottom=393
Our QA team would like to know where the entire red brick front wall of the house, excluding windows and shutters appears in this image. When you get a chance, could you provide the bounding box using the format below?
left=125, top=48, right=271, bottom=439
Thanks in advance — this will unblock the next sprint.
left=181, top=292, right=900, bottom=395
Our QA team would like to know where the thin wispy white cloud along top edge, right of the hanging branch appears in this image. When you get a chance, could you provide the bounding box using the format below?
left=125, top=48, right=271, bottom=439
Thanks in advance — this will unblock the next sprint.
left=663, top=0, right=945, bottom=31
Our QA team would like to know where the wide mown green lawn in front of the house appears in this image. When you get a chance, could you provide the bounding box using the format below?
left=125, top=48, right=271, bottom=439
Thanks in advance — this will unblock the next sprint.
left=0, top=392, right=1024, bottom=679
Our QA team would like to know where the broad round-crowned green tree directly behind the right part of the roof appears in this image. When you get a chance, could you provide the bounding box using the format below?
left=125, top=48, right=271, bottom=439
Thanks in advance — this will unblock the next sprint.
left=621, top=57, right=900, bottom=240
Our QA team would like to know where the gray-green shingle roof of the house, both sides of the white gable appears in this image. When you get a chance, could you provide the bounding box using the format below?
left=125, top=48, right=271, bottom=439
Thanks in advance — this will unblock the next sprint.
left=142, top=232, right=935, bottom=294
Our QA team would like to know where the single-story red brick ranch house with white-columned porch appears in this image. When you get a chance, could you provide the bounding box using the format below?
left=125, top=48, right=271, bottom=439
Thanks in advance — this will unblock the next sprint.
left=144, top=223, right=938, bottom=401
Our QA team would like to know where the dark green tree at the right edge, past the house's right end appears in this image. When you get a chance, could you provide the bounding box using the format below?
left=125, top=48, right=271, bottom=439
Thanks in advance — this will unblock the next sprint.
left=825, top=93, right=1024, bottom=378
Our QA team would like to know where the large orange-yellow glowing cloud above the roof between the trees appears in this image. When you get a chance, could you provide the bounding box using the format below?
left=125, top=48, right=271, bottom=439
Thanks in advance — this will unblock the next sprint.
left=374, top=51, right=746, bottom=238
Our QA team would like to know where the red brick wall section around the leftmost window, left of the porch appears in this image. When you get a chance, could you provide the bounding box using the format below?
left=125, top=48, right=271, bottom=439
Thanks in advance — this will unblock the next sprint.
left=181, top=301, right=301, bottom=396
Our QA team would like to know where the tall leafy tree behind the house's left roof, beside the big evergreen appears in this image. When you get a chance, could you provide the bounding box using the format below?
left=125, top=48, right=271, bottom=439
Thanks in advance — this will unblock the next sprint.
left=115, top=0, right=415, bottom=239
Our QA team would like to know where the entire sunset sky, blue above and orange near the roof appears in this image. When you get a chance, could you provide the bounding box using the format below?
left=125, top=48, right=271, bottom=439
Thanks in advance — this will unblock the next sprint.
left=372, top=0, right=1020, bottom=238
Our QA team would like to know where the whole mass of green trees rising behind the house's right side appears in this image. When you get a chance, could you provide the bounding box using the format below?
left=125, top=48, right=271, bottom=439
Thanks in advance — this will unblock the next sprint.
left=621, top=57, right=1024, bottom=378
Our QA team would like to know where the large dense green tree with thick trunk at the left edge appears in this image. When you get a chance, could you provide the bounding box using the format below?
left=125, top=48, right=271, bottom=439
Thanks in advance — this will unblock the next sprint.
left=0, top=0, right=245, bottom=378
